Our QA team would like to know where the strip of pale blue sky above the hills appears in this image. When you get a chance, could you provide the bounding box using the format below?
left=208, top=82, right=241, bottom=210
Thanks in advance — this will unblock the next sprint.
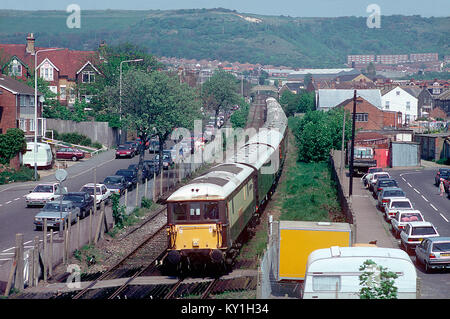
left=0, top=0, right=450, bottom=17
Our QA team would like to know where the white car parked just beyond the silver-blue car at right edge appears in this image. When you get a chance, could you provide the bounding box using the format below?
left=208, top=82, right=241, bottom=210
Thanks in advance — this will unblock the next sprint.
left=400, top=222, right=439, bottom=253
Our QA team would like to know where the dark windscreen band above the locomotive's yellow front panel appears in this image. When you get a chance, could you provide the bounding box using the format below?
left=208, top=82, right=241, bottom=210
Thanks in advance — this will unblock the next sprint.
left=169, top=202, right=219, bottom=222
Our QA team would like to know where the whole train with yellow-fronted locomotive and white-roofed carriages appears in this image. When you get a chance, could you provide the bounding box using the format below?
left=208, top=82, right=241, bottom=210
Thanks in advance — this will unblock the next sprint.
left=164, top=98, right=287, bottom=269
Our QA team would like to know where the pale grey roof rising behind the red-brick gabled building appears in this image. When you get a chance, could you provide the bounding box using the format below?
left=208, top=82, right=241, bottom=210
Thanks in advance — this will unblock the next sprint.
left=316, top=89, right=381, bottom=111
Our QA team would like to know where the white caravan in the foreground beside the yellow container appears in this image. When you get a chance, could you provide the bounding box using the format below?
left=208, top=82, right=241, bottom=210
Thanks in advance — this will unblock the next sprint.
left=302, top=246, right=417, bottom=299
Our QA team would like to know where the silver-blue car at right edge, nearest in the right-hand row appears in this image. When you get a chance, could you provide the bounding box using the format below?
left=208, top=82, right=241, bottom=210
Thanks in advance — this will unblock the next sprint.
left=416, top=237, right=450, bottom=272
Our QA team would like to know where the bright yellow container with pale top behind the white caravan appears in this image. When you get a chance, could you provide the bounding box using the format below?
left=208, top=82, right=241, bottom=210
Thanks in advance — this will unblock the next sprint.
left=278, top=221, right=352, bottom=280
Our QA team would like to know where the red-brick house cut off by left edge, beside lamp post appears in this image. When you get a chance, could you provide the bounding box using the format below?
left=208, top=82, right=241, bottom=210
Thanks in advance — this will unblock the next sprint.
left=0, top=75, right=45, bottom=139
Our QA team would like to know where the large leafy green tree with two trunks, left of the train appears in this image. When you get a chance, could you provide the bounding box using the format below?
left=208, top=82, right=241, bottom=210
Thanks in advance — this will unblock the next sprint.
left=103, top=69, right=201, bottom=178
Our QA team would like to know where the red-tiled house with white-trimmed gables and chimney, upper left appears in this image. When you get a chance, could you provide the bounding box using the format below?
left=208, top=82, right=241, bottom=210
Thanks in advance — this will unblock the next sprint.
left=0, top=33, right=101, bottom=106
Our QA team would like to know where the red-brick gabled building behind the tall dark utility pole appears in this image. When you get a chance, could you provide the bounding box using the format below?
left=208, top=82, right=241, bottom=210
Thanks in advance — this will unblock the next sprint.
left=336, top=96, right=402, bottom=131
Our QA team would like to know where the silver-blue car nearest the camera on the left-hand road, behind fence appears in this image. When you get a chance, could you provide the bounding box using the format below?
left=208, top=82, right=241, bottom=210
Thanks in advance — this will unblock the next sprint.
left=34, top=201, right=80, bottom=230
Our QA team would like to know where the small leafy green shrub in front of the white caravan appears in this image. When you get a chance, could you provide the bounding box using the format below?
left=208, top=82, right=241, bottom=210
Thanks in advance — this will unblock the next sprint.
left=359, top=259, right=398, bottom=299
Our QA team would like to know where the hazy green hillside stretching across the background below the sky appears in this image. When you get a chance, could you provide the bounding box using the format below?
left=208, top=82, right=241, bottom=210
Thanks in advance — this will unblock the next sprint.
left=0, top=9, right=450, bottom=67
